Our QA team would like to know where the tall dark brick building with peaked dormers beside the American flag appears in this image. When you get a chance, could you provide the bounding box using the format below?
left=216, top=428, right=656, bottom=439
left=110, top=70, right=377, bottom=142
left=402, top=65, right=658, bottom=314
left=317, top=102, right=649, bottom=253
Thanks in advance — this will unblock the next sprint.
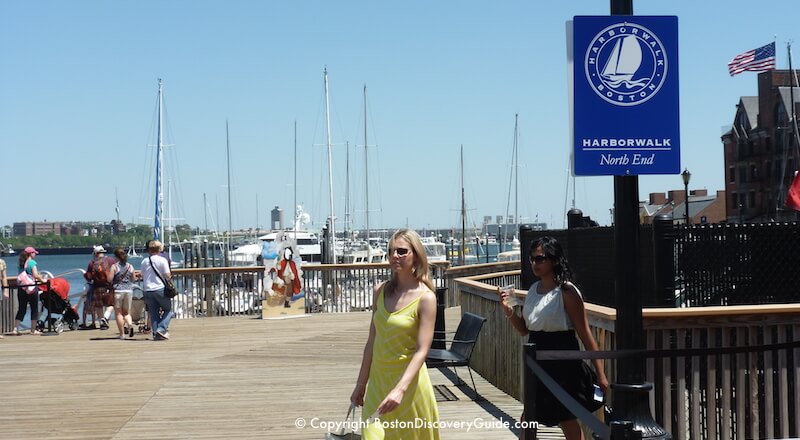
left=722, top=70, right=800, bottom=223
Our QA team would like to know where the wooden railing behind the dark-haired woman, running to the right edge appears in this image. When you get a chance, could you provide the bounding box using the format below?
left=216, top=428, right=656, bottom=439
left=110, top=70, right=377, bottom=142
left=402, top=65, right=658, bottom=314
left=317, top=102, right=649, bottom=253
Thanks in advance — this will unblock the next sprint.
left=451, top=273, right=800, bottom=440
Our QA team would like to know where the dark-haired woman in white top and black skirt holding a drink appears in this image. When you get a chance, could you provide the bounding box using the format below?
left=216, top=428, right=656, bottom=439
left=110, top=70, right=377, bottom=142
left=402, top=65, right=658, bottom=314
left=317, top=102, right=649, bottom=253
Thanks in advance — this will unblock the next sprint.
left=500, top=237, right=608, bottom=440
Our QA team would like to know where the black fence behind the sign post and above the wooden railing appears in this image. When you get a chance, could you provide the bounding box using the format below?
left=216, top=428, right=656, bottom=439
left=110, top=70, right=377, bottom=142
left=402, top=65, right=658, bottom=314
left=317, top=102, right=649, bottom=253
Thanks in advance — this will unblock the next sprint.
left=520, top=218, right=800, bottom=307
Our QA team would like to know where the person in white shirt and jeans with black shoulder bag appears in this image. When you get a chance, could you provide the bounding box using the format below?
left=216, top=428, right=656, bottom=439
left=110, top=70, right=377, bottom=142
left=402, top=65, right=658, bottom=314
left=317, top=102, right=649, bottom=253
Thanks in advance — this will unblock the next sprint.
left=141, top=240, right=174, bottom=341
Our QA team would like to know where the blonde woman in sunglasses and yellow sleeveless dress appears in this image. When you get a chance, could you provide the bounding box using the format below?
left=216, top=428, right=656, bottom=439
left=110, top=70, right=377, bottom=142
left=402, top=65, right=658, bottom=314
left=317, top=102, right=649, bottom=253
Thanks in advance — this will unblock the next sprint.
left=350, top=229, right=439, bottom=440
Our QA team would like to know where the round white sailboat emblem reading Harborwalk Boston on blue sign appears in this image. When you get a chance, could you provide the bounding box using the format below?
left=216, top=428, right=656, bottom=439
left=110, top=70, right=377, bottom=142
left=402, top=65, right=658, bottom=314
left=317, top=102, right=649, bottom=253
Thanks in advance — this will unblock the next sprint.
left=584, top=23, right=667, bottom=106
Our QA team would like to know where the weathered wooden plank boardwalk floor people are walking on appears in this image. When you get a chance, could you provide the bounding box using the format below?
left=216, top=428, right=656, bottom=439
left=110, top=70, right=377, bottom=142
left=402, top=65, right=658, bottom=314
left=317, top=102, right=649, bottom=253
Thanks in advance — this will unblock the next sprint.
left=0, top=309, right=560, bottom=440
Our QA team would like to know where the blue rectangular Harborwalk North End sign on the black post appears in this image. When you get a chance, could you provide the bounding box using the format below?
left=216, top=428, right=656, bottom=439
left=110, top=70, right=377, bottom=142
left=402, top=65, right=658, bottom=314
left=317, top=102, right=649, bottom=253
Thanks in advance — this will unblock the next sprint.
left=573, top=15, right=680, bottom=176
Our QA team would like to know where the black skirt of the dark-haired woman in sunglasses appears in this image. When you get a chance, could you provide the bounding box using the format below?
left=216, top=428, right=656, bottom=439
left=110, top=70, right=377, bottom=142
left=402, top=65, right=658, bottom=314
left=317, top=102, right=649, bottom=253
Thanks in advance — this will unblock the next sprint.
left=526, top=330, right=584, bottom=426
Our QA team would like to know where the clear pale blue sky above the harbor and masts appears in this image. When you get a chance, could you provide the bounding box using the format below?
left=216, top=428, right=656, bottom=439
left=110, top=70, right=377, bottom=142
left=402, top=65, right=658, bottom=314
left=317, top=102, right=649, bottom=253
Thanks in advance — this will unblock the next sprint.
left=0, top=0, right=797, bottom=235
